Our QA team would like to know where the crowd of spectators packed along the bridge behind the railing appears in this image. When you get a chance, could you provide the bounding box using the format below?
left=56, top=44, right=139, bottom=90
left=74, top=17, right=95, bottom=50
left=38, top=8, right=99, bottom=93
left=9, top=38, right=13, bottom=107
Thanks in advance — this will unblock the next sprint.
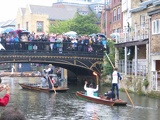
left=0, top=30, right=107, bottom=52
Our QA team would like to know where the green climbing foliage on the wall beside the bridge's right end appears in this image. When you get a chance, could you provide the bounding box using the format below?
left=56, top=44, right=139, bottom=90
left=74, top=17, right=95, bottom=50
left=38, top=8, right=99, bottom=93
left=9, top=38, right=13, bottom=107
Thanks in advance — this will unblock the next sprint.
left=102, top=39, right=115, bottom=76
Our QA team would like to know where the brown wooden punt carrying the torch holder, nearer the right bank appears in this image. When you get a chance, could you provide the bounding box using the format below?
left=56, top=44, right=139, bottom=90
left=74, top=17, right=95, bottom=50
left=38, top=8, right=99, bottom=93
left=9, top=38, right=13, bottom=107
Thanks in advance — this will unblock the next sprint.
left=76, top=91, right=127, bottom=106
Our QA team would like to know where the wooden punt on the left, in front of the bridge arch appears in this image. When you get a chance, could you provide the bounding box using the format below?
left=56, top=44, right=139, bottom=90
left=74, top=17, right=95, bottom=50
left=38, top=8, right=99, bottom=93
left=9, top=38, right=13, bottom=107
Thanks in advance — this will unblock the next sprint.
left=18, top=83, right=69, bottom=92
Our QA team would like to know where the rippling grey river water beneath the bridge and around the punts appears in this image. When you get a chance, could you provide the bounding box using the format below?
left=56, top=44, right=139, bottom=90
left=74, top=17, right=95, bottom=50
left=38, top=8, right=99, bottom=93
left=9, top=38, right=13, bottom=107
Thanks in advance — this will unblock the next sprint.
left=0, top=77, right=160, bottom=120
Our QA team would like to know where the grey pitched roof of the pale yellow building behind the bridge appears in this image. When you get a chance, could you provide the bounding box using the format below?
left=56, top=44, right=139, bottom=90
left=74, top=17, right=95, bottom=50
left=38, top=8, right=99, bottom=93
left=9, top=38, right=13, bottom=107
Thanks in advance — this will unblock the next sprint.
left=29, top=3, right=90, bottom=20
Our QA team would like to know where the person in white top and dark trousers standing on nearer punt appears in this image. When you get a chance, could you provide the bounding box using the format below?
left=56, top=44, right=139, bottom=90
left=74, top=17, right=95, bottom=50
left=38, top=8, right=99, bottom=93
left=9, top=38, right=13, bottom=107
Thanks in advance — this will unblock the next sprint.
left=112, top=67, right=122, bottom=100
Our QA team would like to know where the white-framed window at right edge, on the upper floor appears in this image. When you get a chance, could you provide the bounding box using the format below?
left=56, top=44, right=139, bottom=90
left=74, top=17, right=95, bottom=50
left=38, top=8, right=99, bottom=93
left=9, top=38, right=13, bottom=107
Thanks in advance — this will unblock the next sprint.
left=152, top=19, right=160, bottom=34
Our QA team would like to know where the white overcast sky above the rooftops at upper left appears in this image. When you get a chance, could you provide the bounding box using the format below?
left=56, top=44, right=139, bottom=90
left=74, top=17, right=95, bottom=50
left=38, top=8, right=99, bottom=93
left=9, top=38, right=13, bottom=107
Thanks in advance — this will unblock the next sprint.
left=0, top=0, right=55, bottom=22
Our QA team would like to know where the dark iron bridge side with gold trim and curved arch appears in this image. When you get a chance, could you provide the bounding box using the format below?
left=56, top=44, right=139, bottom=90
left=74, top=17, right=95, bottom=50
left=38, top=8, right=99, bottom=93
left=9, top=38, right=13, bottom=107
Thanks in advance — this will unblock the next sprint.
left=0, top=42, right=104, bottom=74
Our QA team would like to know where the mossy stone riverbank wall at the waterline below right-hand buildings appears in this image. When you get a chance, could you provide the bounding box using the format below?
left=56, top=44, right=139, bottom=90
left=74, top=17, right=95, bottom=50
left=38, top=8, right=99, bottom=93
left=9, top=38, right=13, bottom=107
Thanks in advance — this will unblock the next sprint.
left=100, top=75, right=160, bottom=98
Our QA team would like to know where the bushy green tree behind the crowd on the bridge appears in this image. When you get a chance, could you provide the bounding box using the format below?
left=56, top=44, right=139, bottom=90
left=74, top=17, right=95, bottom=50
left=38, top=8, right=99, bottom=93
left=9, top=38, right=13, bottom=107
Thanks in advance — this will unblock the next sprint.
left=49, top=13, right=100, bottom=35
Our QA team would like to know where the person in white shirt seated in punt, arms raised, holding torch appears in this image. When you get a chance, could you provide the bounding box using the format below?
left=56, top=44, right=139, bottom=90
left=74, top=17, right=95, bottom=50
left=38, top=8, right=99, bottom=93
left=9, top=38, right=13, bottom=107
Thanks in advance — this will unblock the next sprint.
left=84, top=81, right=98, bottom=97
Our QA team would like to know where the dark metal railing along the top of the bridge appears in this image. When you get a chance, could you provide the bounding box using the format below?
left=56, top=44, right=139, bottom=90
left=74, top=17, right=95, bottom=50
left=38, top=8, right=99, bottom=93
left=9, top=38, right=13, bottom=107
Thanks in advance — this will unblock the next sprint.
left=0, top=41, right=105, bottom=56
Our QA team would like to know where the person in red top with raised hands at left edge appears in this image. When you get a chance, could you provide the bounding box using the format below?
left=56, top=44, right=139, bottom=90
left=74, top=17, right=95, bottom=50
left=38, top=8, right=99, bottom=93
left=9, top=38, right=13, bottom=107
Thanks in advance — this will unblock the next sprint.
left=0, top=84, right=10, bottom=106
